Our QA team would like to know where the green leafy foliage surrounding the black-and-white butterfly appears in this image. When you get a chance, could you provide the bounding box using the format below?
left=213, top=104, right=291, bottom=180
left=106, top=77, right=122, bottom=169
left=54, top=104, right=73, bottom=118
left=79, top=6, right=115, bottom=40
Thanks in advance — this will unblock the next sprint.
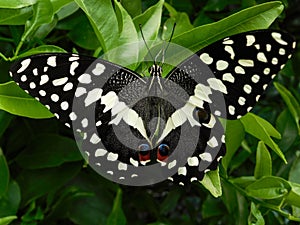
left=0, top=0, right=300, bottom=225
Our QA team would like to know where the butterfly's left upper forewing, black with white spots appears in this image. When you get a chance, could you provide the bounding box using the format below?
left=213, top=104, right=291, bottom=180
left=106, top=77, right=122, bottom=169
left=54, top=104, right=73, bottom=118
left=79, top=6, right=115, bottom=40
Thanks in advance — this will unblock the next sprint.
left=10, top=53, right=145, bottom=127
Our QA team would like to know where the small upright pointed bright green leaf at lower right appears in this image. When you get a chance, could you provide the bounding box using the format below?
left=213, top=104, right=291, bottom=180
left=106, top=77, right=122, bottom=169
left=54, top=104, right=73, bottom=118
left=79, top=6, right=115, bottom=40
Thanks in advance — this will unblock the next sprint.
left=254, top=141, right=272, bottom=179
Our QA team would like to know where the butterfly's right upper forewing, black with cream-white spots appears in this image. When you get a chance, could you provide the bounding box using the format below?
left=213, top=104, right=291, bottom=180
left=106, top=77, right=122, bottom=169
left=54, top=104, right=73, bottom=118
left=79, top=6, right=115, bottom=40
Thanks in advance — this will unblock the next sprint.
left=167, top=30, right=296, bottom=119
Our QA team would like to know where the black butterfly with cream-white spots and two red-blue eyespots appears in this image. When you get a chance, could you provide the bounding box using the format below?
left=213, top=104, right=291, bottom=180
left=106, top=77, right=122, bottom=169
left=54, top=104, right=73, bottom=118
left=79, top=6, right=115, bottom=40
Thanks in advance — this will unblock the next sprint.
left=10, top=30, right=296, bottom=186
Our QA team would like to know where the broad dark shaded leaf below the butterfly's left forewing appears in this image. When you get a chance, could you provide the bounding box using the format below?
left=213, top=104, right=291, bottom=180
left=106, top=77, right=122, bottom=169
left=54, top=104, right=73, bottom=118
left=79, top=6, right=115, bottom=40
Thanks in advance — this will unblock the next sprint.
left=16, top=134, right=82, bottom=169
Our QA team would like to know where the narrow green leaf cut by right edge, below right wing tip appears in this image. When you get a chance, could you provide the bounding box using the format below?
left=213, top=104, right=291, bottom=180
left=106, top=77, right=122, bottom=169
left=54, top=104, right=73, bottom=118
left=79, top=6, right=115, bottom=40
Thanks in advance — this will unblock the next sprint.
left=274, top=82, right=300, bottom=135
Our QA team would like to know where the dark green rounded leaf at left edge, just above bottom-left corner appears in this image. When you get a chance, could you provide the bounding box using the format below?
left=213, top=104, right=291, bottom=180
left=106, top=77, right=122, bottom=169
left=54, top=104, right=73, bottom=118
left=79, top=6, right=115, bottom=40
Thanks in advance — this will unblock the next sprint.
left=0, top=181, right=21, bottom=217
